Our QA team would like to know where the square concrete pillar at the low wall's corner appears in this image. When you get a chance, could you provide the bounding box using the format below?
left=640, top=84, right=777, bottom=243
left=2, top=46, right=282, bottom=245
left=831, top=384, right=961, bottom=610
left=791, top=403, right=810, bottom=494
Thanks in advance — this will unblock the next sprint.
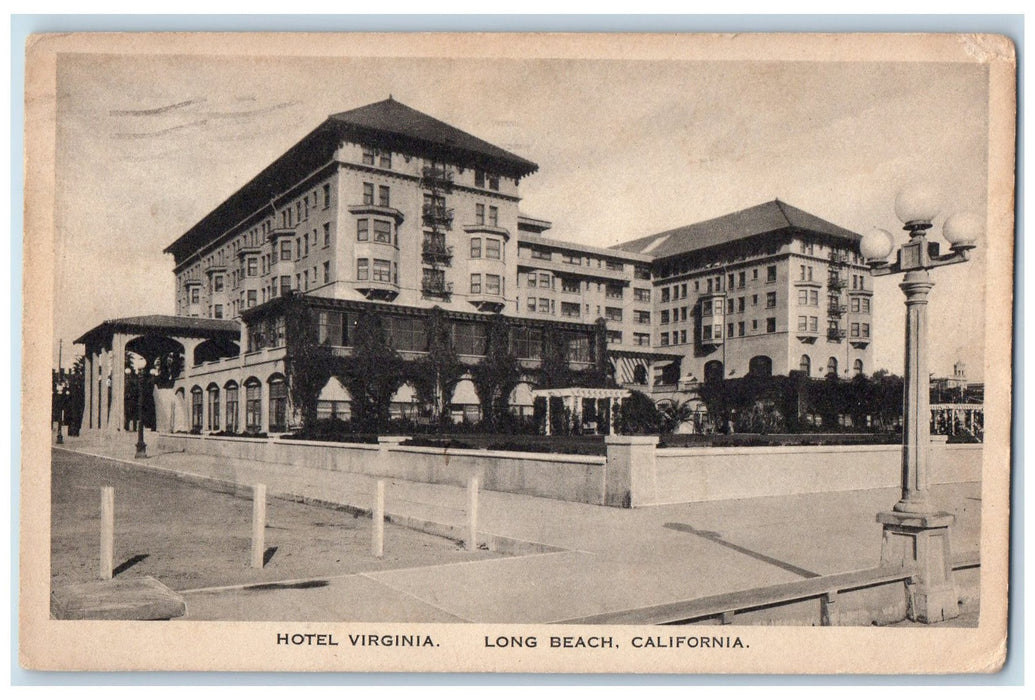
left=603, top=435, right=657, bottom=508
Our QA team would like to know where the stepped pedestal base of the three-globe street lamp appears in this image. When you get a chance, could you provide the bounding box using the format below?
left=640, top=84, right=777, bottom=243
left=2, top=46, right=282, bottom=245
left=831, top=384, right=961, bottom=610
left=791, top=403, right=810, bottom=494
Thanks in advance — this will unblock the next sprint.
left=877, top=512, right=959, bottom=623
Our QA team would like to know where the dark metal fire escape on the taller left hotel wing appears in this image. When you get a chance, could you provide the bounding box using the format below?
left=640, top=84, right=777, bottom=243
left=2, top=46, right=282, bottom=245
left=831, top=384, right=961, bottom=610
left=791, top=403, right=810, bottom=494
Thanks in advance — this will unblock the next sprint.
left=420, top=162, right=453, bottom=300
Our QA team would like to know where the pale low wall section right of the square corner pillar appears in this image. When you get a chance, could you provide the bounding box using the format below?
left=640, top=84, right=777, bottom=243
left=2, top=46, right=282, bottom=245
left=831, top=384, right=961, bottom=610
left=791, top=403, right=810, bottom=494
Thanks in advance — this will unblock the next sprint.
left=642, top=442, right=982, bottom=504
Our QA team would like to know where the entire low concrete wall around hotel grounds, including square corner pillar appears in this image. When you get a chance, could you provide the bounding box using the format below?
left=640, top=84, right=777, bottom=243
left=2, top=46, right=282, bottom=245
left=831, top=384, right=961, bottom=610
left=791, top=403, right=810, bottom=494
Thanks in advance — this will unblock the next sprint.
left=158, top=434, right=982, bottom=507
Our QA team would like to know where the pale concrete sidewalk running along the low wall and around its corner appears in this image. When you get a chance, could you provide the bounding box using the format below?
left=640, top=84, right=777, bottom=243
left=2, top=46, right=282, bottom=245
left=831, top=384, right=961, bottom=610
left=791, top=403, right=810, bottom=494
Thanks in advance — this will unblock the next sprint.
left=54, top=435, right=981, bottom=623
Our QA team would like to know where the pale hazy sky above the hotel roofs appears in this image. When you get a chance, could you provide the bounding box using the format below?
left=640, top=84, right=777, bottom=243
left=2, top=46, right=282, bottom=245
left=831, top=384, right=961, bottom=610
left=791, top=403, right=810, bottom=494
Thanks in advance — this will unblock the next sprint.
left=52, top=54, right=988, bottom=380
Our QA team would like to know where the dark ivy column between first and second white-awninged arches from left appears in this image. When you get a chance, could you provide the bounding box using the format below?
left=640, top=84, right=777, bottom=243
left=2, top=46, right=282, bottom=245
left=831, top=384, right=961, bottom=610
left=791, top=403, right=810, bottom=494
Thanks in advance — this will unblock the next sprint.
left=343, top=310, right=407, bottom=433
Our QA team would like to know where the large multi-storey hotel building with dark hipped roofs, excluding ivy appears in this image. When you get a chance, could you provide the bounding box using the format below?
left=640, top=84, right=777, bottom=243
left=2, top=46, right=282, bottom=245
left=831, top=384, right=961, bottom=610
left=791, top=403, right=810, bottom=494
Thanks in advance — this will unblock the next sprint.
left=77, top=97, right=874, bottom=432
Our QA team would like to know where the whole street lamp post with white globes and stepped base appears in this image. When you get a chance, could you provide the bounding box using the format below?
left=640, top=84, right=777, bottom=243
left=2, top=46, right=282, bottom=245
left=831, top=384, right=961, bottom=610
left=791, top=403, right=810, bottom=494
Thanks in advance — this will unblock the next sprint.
left=861, top=188, right=981, bottom=622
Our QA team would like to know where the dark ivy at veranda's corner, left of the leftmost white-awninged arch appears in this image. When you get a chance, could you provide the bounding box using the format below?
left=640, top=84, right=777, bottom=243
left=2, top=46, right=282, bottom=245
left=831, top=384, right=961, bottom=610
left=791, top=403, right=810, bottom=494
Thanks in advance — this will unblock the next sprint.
left=284, top=294, right=341, bottom=432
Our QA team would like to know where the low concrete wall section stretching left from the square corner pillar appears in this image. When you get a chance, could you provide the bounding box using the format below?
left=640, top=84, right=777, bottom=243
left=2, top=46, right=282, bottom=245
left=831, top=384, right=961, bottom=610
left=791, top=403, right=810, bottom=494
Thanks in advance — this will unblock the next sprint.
left=158, top=434, right=605, bottom=504
